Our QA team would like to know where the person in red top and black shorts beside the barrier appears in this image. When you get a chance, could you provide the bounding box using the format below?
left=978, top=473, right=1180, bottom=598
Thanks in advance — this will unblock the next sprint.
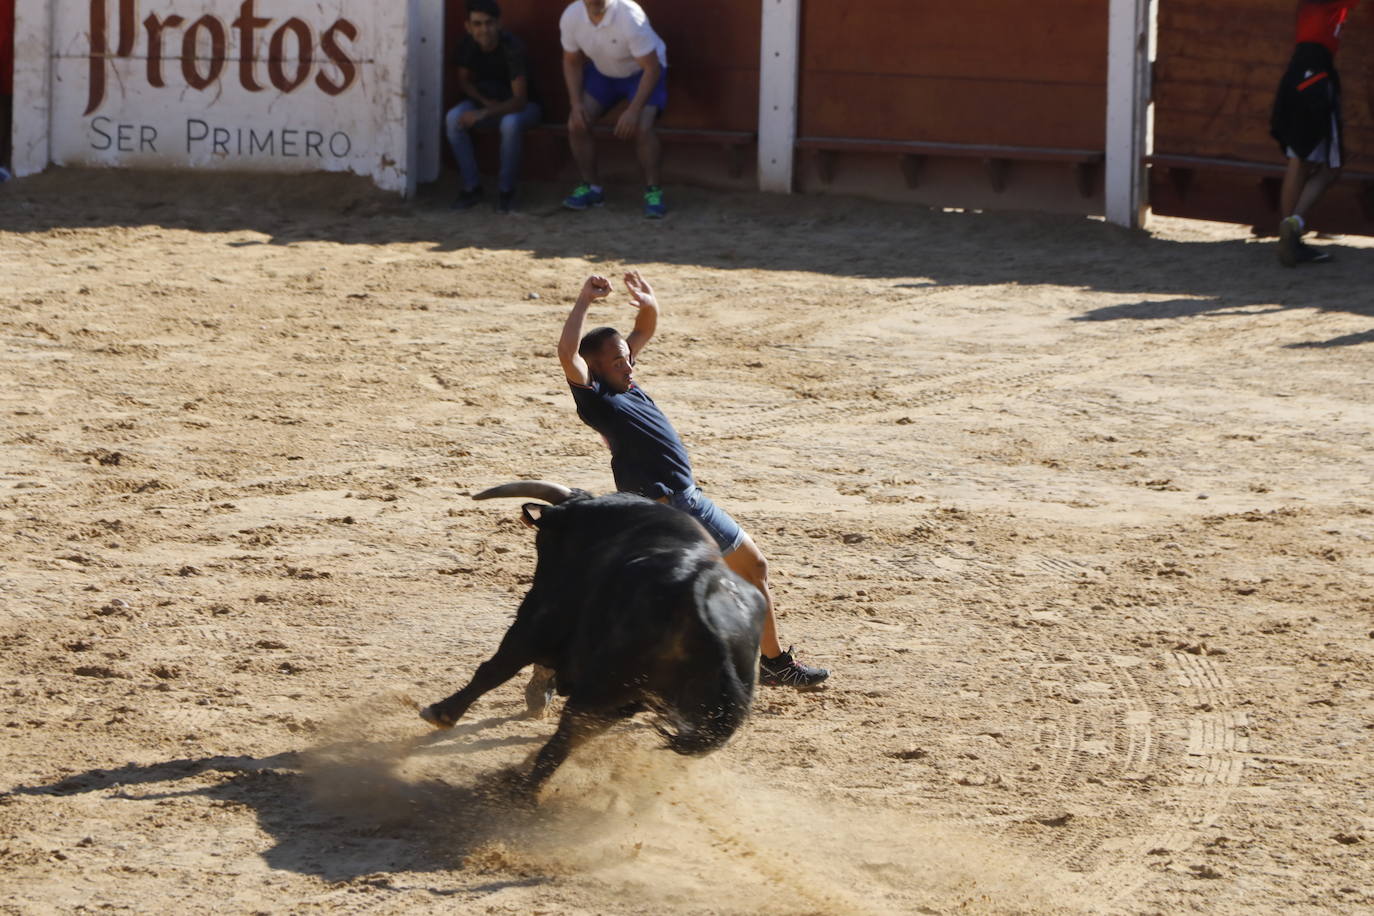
left=1270, top=0, right=1359, bottom=268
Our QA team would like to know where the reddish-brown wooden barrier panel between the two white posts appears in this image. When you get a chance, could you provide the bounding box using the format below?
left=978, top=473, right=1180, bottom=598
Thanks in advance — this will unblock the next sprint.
left=797, top=0, right=1109, bottom=213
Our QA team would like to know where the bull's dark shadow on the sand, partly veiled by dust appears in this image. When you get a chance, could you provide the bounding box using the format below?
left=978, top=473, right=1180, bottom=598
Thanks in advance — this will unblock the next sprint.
left=10, top=717, right=548, bottom=893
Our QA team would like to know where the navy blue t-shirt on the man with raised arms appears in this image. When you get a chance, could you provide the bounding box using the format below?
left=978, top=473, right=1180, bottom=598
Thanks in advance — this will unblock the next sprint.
left=567, top=379, right=695, bottom=500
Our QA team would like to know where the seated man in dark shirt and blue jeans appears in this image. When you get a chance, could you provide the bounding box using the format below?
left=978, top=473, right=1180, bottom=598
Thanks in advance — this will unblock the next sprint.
left=444, top=0, right=543, bottom=213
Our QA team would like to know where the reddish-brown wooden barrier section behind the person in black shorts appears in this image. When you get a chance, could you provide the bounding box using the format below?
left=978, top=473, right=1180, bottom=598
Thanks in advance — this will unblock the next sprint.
left=1150, top=0, right=1374, bottom=233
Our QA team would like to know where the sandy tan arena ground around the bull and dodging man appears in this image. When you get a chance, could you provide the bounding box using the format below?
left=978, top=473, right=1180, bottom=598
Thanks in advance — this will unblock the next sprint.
left=0, top=172, right=1374, bottom=915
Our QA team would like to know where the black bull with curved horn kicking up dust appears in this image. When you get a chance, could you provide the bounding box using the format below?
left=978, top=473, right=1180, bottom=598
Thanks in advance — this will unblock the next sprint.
left=420, top=481, right=765, bottom=792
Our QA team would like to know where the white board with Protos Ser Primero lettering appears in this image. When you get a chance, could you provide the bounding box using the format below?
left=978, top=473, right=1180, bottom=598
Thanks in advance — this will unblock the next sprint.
left=48, top=0, right=428, bottom=194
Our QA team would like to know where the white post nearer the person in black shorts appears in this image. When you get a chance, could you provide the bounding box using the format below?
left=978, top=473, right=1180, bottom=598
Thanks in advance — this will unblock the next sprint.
left=1105, top=0, right=1154, bottom=229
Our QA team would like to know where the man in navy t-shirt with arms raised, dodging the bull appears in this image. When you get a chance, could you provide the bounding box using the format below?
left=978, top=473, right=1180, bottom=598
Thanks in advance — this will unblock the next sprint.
left=558, top=271, right=830, bottom=688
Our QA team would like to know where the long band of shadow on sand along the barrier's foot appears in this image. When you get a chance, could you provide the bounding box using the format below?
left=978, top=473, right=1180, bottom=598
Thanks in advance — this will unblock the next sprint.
left=0, top=169, right=1374, bottom=347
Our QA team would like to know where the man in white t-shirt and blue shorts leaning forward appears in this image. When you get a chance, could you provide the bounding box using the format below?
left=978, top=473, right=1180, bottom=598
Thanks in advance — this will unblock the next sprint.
left=558, top=0, right=668, bottom=220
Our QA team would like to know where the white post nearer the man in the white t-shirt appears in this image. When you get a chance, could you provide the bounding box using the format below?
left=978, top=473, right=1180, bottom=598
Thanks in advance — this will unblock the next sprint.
left=758, top=0, right=801, bottom=194
